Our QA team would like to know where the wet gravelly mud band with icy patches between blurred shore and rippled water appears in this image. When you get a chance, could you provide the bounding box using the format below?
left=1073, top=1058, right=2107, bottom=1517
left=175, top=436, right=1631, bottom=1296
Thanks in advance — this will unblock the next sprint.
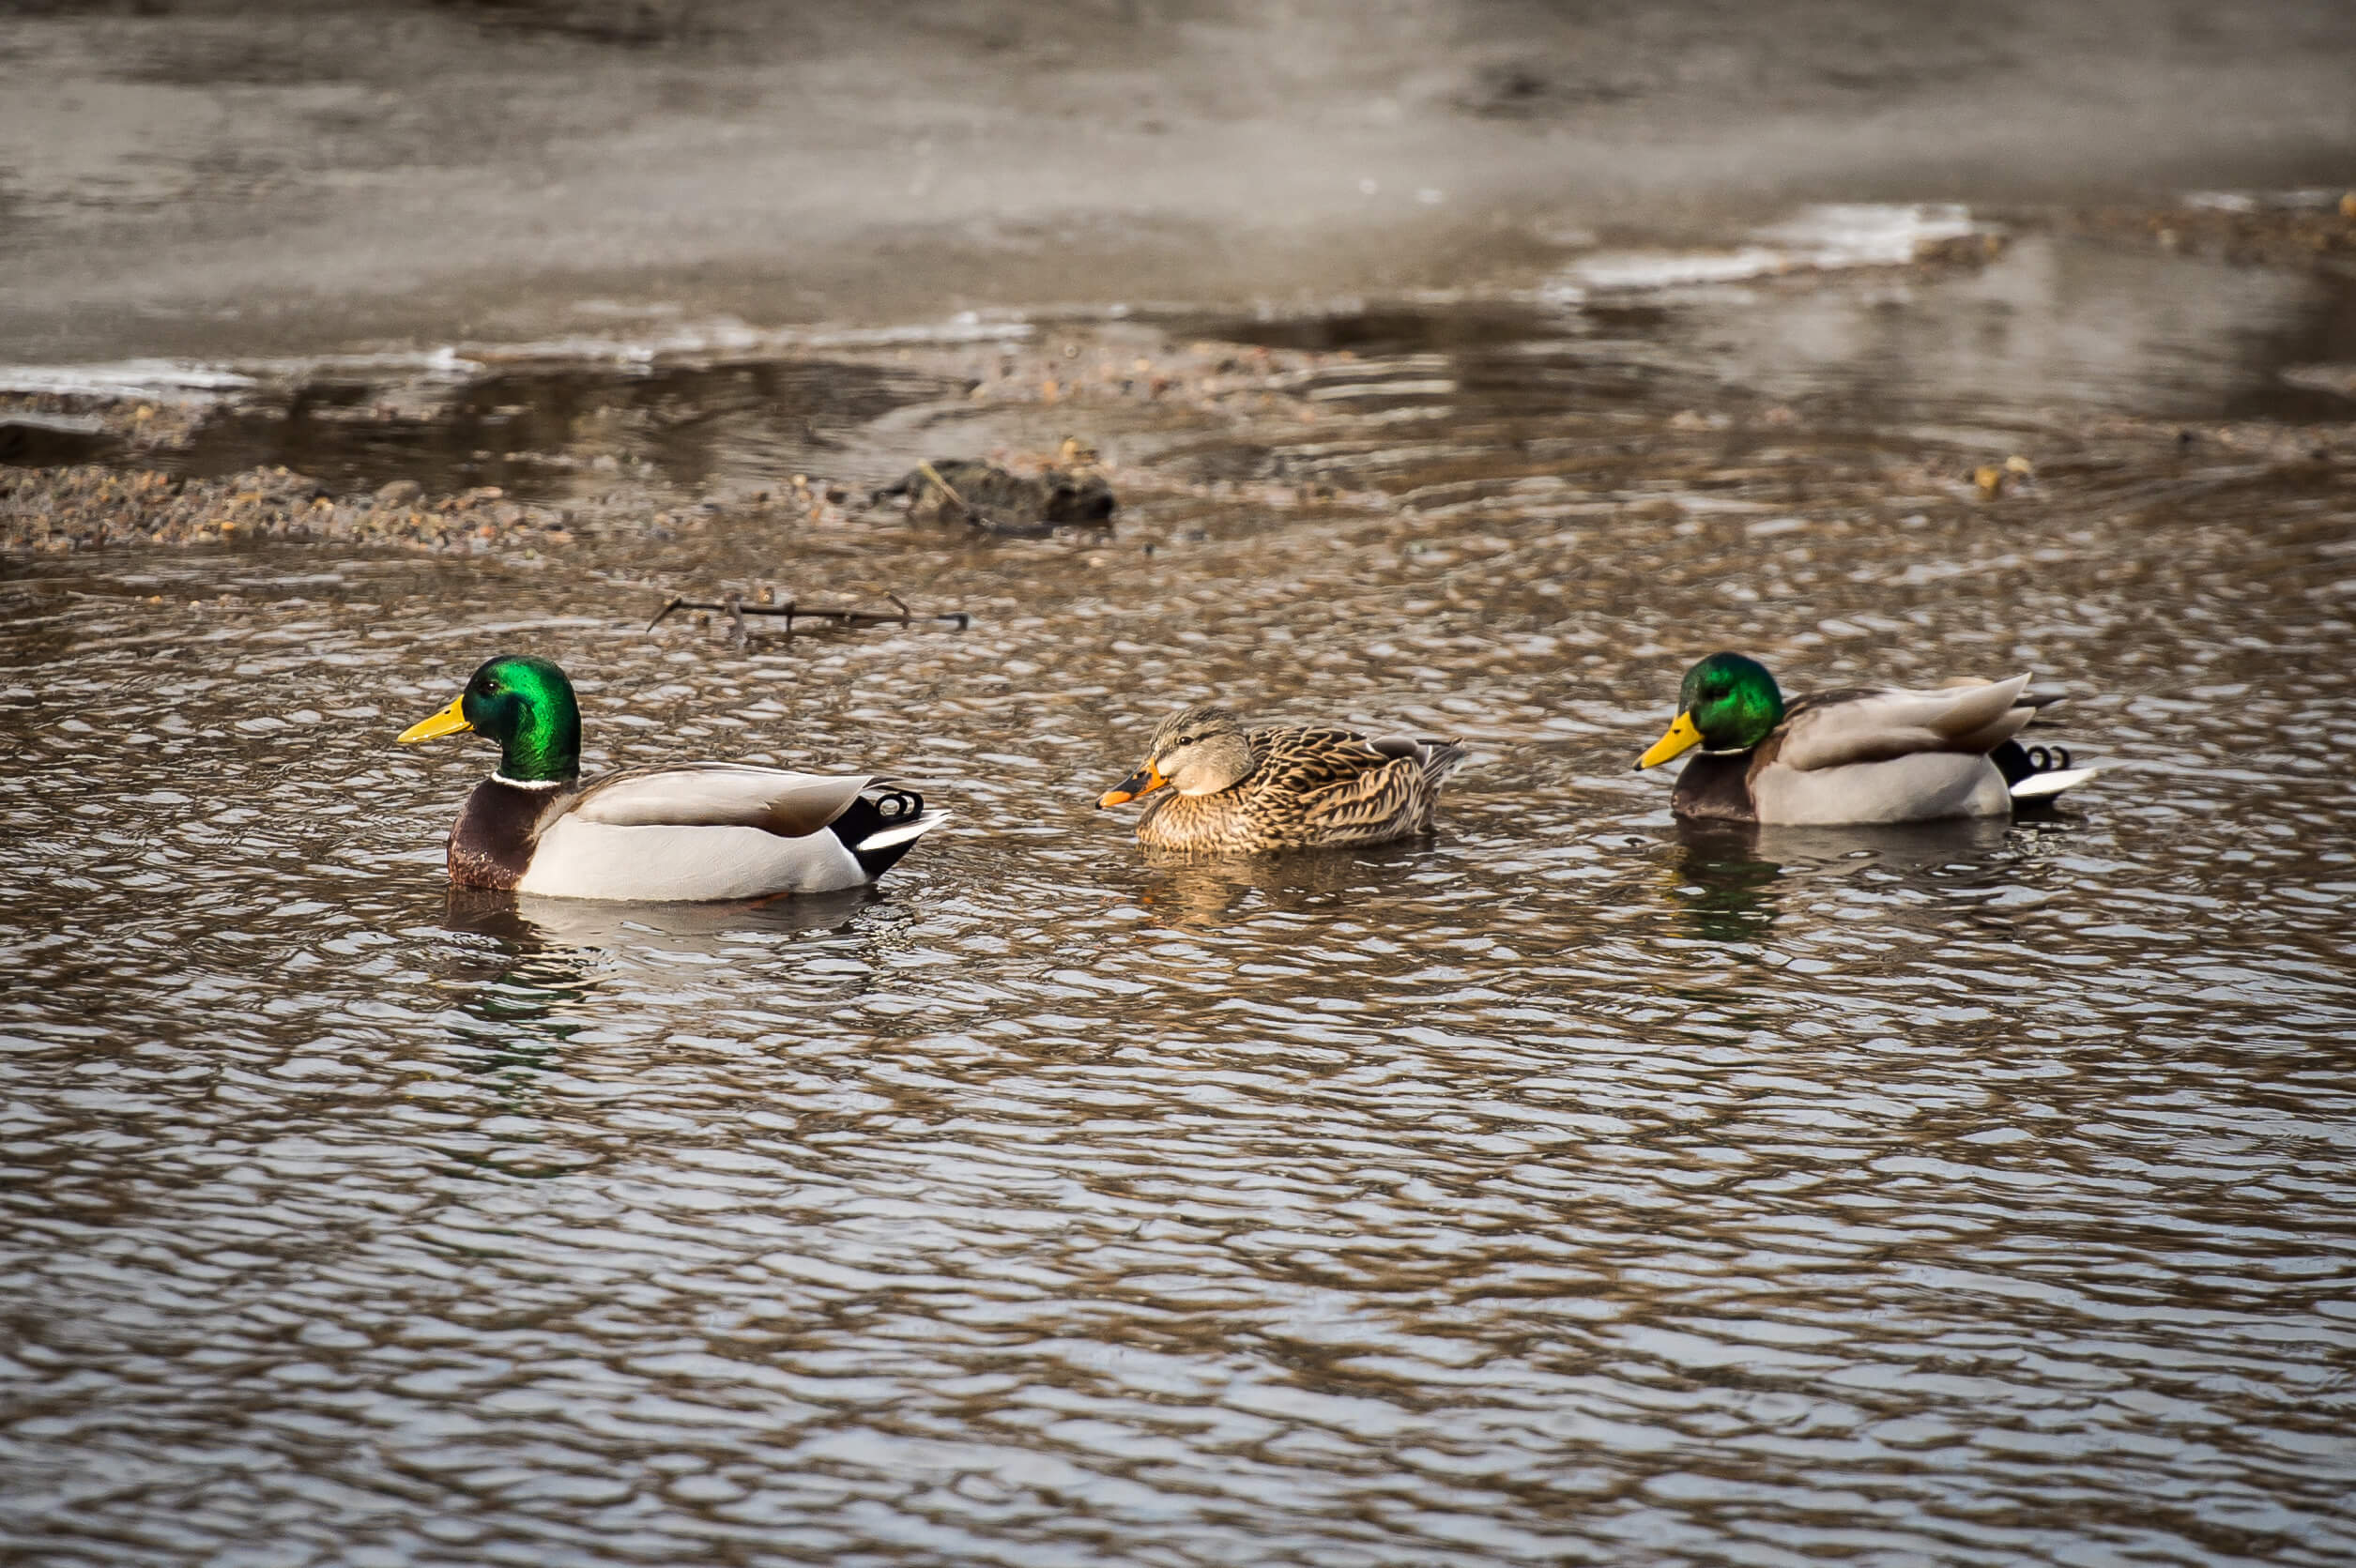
left=0, top=193, right=2356, bottom=558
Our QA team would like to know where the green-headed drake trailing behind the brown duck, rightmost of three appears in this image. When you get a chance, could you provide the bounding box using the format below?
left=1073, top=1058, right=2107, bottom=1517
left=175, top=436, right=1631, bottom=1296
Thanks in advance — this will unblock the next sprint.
left=1637, top=652, right=2099, bottom=827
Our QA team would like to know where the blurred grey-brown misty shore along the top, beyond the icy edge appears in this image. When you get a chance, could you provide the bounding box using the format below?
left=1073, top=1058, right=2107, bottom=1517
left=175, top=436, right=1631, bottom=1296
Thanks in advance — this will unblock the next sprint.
left=0, top=0, right=2356, bottom=362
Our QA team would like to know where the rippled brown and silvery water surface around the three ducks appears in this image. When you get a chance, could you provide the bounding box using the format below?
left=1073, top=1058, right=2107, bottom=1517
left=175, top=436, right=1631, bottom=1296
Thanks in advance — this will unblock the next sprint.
left=0, top=251, right=2356, bottom=1568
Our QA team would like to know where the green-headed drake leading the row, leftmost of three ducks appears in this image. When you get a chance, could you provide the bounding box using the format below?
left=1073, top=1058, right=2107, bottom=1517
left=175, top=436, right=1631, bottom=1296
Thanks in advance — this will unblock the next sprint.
left=401, top=655, right=945, bottom=902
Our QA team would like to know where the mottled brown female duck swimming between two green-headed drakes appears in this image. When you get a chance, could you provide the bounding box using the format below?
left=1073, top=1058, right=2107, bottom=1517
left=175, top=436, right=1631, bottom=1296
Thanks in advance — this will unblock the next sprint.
left=1095, top=707, right=1465, bottom=855
